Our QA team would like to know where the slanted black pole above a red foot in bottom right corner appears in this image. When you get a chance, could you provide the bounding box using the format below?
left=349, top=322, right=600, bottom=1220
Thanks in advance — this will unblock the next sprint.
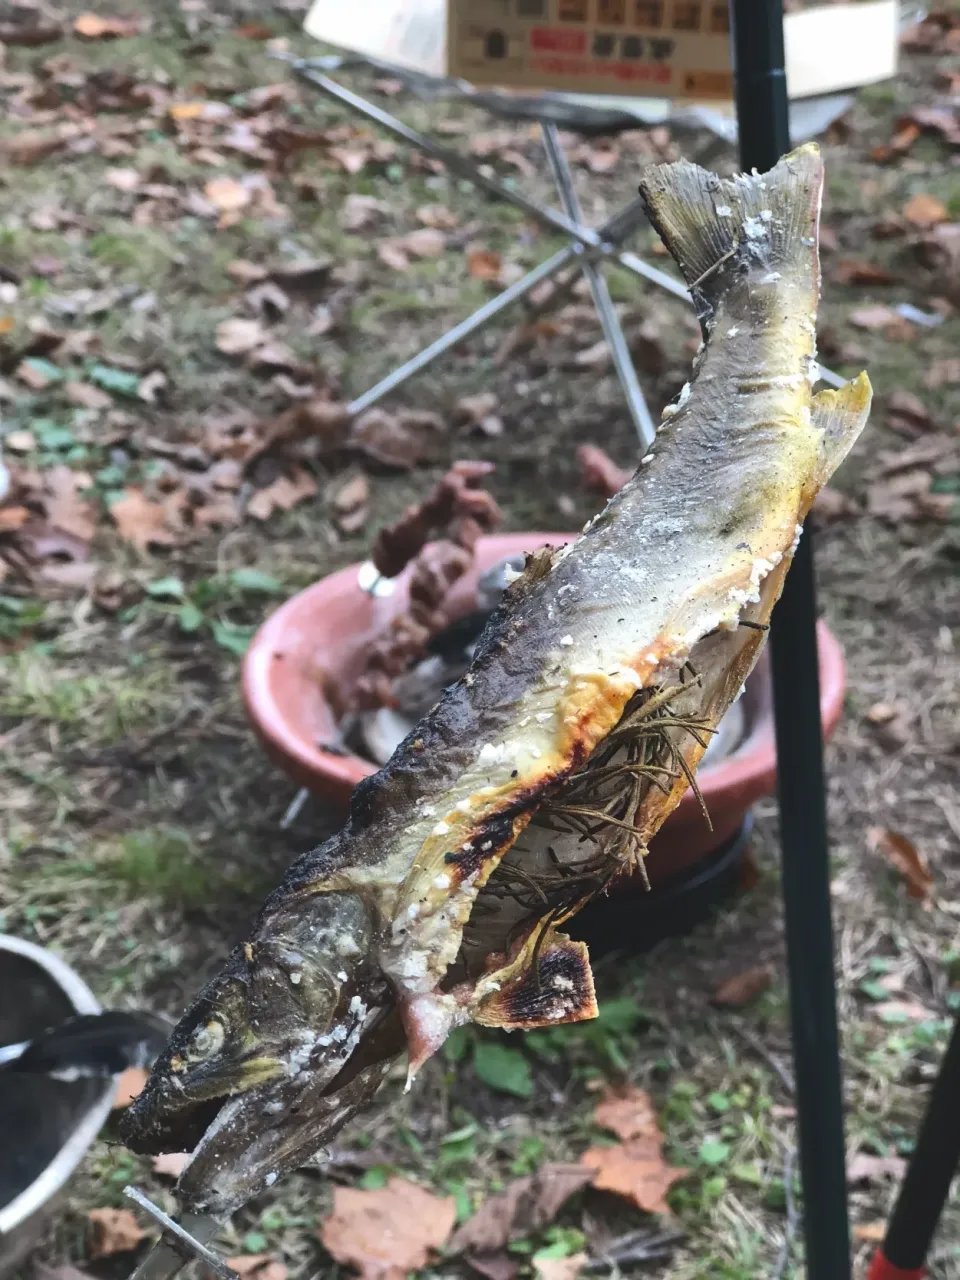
left=870, top=1021, right=960, bottom=1277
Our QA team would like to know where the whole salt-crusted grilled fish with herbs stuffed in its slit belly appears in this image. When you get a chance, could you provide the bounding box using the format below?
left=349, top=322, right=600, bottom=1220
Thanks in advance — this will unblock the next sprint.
left=120, top=146, right=870, bottom=1212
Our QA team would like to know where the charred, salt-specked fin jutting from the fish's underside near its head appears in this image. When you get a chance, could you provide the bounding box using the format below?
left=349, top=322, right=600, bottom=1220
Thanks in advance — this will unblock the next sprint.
left=471, top=927, right=598, bottom=1030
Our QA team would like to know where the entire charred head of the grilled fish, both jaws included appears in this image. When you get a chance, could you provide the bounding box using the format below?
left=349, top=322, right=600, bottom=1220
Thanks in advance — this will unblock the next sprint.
left=122, top=884, right=403, bottom=1212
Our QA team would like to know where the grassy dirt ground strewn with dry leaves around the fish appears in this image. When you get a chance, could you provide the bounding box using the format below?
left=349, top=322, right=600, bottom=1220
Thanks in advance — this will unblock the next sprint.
left=0, top=0, right=960, bottom=1280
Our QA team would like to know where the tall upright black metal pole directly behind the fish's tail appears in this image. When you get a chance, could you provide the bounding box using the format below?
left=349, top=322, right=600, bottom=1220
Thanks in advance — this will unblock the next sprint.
left=731, top=0, right=850, bottom=1280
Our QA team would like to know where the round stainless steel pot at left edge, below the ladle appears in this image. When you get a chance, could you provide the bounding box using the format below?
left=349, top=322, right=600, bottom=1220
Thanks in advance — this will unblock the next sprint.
left=0, top=934, right=115, bottom=1277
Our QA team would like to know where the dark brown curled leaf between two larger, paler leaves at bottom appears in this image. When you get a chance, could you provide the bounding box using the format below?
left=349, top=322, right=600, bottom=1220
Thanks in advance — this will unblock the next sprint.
left=449, top=1164, right=593, bottom=1254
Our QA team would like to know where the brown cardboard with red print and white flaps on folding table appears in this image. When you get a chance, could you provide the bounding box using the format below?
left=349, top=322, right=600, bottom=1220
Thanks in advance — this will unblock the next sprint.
left=305, top=0, right=897, bottom=101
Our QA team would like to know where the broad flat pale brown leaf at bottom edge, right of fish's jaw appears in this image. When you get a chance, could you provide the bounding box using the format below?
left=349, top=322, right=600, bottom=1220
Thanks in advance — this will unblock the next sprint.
left=320, top=1178, right=457, bottom=1280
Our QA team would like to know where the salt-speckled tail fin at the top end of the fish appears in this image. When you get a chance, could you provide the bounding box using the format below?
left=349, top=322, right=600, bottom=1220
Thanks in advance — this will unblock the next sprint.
left=640, top=142, right=823, bottom=311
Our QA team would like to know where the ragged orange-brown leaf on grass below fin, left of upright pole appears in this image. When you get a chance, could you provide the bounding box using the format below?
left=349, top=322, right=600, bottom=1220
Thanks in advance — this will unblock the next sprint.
left=580, top=1087, right=689, bottom=1213
